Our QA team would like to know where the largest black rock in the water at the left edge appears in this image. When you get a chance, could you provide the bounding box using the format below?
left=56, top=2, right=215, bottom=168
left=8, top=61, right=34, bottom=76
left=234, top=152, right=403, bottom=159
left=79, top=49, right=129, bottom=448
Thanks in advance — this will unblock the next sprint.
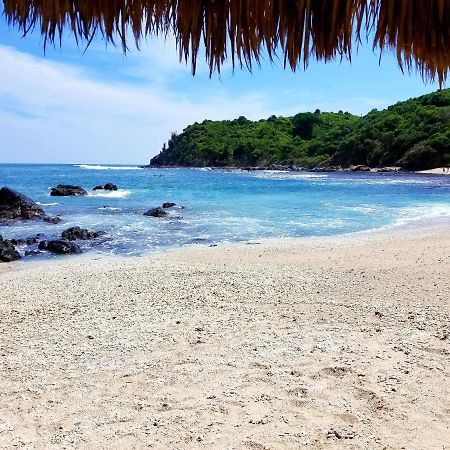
left=0, top=187, right=45, bottom=221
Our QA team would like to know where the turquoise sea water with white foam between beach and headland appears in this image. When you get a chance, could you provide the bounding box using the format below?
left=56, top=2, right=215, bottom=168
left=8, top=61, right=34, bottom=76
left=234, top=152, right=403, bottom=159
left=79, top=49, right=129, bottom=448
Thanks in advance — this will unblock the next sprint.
left=0, top=165, right=450, bottom=255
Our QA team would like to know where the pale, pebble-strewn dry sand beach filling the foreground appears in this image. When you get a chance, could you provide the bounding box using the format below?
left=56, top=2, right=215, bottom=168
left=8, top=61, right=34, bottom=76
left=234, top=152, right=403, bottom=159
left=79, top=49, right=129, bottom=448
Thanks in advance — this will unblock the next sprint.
left=0, top=229, right=450, bottom=449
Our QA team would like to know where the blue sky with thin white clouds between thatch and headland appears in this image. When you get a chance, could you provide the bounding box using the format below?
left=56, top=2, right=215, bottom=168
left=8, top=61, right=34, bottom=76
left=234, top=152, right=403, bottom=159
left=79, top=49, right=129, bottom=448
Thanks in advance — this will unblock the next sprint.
left=0, top=17, right=437, bottom=164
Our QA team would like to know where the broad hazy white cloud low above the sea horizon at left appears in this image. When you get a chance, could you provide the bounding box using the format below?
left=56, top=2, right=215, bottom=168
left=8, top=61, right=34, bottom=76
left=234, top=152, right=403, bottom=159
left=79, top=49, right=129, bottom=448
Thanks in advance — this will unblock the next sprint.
left=0, top=46, right=269, bottom=163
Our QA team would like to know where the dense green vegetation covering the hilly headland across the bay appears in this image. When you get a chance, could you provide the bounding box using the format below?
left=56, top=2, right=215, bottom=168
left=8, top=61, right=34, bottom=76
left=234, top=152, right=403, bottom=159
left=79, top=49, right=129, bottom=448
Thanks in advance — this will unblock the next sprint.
left=151, top=89, right=450, bottom=170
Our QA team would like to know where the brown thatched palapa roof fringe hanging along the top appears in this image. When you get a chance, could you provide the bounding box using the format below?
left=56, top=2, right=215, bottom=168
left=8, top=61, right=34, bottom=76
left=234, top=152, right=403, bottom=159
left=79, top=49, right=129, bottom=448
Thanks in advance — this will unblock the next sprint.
left=3, top=0, right=450, bottom=84
